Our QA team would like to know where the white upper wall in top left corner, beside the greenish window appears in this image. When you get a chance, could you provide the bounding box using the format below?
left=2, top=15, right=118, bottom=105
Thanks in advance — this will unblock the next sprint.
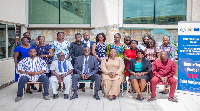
left=0, top=0, right=26, bottom=24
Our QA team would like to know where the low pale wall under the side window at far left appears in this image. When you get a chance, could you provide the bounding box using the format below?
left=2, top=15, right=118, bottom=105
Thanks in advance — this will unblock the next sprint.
left=0, top=59, right=15, bottom=85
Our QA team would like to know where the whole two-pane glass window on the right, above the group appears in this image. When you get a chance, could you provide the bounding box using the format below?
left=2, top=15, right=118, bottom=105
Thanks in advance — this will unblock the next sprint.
left=123, top=0, right=187, bottom=24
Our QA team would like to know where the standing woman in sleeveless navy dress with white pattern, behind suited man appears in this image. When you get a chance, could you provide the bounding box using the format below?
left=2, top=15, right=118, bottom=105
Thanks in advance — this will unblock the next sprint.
left=92, top=33, right=107, bottom=72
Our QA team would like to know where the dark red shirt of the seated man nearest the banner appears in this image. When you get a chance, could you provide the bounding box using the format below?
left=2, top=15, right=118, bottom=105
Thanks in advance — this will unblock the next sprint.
left=151, top=59, right=176, bottom=77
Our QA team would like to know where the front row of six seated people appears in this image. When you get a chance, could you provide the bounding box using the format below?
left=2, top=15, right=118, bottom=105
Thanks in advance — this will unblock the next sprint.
left=15, top=47, right=177, bottom=102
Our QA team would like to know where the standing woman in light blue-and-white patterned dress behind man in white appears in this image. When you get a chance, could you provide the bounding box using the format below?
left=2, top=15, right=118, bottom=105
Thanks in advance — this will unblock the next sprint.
left=51, top=32, right=70, bottom=91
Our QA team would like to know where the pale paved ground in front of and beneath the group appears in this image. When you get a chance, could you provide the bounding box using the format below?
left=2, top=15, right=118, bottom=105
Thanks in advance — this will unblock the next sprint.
left=0, top=83, right=200, bottom=111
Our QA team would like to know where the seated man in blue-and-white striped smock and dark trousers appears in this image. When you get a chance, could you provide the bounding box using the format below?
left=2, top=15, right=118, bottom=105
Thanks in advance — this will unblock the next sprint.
left=15, top=48, right=50, bottom=102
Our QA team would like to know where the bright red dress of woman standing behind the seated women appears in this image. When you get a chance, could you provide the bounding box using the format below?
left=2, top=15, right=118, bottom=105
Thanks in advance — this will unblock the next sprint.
left=124, top=49, right=137, bottom=76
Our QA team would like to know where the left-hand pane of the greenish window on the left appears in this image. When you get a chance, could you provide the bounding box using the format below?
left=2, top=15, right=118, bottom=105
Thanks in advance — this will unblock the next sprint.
left=29, top=0, right=59, bottom=24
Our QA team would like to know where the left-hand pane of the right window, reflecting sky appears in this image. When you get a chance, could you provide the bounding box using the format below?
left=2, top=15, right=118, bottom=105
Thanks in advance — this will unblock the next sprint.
left=123, top=0, right=154, bottom=24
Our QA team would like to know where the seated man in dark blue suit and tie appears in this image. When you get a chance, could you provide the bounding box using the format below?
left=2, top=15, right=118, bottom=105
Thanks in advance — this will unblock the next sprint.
left=70, top=47, right=101, bottom=100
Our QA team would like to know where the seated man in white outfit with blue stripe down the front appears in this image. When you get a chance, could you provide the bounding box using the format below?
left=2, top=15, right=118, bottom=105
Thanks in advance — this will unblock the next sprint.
left=49, top=52, right=73, bottom=99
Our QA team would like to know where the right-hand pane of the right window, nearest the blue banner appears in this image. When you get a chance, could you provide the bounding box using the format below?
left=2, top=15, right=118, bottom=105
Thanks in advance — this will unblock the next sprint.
left=155, top=0, right=187, bottom=24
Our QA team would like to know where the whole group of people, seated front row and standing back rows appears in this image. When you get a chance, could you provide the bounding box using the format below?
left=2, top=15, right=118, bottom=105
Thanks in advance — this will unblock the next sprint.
left=14, top=32, right=177, bottom=102
